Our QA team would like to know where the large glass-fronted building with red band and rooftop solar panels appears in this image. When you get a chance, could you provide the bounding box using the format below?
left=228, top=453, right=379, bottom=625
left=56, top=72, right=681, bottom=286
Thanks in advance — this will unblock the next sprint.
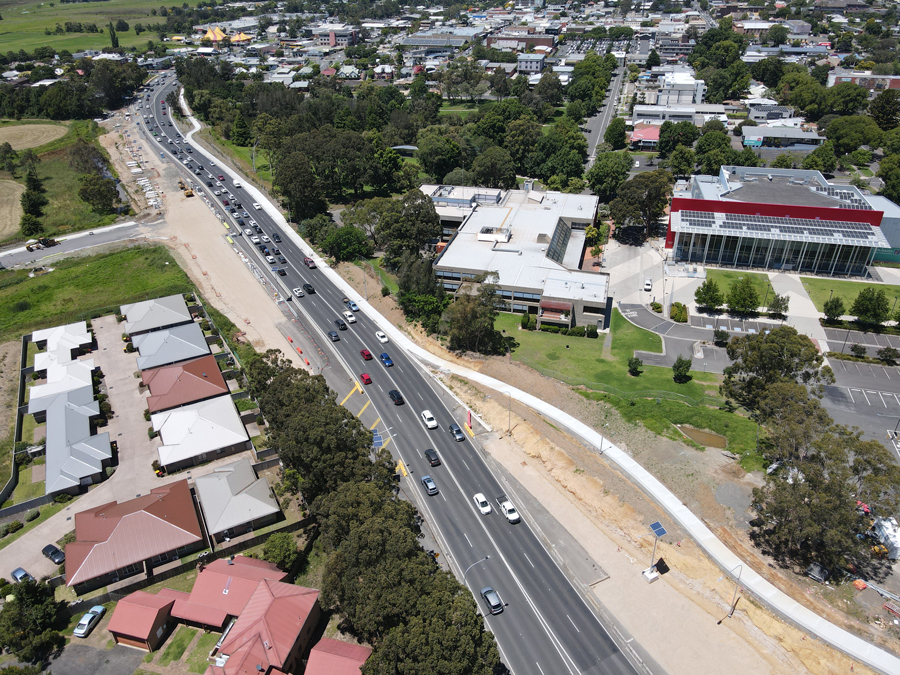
left=666, top=166, right=900, bottom=276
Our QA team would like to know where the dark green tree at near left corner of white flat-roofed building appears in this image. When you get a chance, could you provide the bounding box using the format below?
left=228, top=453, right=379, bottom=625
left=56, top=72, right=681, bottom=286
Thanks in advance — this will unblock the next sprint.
left=442, top=272, right=503, bottom=354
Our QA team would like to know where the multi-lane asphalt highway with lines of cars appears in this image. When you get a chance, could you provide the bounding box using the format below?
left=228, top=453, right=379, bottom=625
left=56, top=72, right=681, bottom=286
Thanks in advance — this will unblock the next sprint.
left=141, top=73, right=645, bottom=675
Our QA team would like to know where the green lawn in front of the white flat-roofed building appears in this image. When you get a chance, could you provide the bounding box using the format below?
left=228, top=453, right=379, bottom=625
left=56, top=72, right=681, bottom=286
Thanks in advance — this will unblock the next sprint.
left=495, top=310, right=719, bottom=401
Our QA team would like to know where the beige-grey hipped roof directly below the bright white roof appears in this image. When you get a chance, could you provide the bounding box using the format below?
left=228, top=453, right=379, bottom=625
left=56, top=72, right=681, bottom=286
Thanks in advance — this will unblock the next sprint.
left=194, top=459, right=280, bottom=534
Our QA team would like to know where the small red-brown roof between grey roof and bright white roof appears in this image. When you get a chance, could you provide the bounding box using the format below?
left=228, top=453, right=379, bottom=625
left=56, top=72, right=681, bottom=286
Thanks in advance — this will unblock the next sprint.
left=141, top=354, right=228, bottom=413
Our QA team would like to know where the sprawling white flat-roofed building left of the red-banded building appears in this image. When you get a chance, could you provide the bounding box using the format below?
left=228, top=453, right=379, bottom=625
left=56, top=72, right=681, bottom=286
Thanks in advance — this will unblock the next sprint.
left=420, top=185, right=609, bottom=328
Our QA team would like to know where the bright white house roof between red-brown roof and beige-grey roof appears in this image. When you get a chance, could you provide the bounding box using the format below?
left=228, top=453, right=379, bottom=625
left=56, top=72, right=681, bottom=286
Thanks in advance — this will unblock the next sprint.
left=150, top=396, right=250, bottom=466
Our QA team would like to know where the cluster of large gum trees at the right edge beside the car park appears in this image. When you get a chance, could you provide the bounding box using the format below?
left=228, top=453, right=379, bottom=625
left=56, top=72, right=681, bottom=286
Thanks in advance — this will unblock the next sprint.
left=721, top=326, right=900, bottom=572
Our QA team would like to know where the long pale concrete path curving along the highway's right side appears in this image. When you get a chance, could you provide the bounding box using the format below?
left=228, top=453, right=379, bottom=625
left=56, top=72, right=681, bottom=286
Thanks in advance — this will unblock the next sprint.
left=180, top=90, right=900, bottom=675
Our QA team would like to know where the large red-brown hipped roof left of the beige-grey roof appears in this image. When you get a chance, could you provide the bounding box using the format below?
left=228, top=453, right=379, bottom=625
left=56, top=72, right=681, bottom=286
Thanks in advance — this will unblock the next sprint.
left=66, top=480, right=203, bottom=586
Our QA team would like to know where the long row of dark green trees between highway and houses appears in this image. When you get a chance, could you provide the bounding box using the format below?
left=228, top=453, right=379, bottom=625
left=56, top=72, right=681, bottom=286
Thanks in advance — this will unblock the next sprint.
left=247, top=350, right=500, bottom=675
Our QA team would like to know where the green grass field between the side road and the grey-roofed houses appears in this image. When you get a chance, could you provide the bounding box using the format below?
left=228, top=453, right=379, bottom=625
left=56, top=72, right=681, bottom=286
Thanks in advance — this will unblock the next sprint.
left=0, top=246, right=192, bottom=340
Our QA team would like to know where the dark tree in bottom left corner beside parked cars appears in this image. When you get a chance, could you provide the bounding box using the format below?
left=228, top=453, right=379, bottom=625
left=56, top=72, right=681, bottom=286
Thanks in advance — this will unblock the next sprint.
left=0, top=581, right=65, bottom=662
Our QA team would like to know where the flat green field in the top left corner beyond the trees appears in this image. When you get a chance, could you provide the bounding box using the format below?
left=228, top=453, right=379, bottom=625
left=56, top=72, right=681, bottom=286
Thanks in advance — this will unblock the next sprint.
left=0, top=0, right=193, bottom=53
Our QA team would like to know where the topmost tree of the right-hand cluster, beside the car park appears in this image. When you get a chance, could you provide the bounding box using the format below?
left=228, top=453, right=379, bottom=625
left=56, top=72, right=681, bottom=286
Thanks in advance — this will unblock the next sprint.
left=720, top=326, right=834, bottom=410
